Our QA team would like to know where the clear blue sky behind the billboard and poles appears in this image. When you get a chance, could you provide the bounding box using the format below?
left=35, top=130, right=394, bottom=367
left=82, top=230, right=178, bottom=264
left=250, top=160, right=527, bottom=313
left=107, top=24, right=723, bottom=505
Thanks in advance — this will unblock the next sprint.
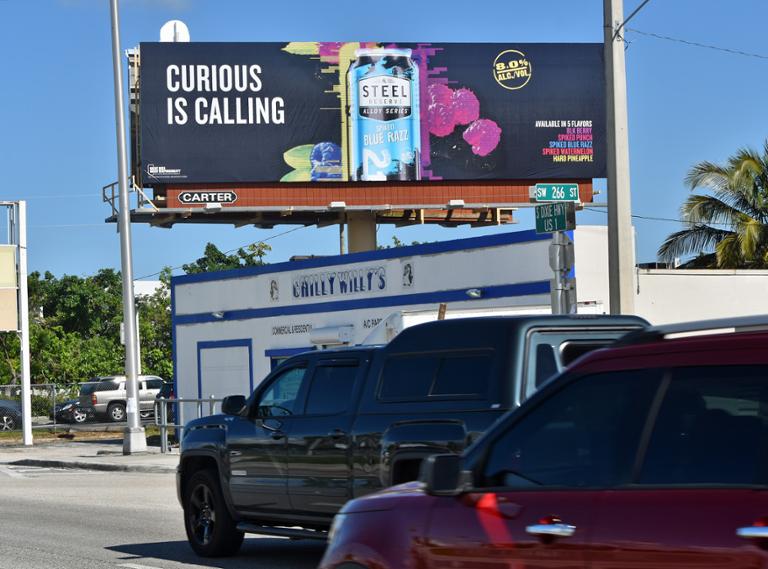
left=0, top=0, right=768, bottom=277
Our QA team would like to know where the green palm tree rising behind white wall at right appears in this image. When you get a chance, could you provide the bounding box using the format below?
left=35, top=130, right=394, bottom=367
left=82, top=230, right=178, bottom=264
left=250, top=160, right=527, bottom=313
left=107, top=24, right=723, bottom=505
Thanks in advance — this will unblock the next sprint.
left=658, top=139, right=768, bottom=269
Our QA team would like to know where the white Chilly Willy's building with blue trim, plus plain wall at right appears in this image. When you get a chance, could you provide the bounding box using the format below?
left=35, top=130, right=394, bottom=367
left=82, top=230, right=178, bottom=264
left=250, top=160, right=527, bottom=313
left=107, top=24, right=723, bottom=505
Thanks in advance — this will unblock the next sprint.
left=171, top=226, right=768, bottom=398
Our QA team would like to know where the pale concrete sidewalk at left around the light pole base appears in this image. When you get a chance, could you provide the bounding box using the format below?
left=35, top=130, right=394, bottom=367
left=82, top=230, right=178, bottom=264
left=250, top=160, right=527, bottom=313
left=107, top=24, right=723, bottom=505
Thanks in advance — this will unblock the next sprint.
left=0, top=440, right=179, bottom=474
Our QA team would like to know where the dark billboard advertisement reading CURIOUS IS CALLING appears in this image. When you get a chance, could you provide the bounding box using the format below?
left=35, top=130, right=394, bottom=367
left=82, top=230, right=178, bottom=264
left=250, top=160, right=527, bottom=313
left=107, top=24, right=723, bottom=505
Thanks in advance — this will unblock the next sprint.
left=140, top=42, right=605, bottom=186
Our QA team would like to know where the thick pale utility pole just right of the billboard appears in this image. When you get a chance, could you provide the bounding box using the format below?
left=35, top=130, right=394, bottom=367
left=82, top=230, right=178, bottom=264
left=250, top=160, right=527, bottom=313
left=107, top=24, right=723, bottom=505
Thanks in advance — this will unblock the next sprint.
left=603, top=0, right=635, bottom=314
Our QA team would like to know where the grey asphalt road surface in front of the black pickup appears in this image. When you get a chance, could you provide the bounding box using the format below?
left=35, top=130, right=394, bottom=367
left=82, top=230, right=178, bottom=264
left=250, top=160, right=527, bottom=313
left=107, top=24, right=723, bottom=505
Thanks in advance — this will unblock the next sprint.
left=0, top=465, right=323, bottom=569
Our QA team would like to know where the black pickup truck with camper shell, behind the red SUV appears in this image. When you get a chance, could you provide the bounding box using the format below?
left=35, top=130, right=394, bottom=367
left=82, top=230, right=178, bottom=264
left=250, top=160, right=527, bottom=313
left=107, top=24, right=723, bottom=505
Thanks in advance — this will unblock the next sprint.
left=177, top=316, right=647, bottom=556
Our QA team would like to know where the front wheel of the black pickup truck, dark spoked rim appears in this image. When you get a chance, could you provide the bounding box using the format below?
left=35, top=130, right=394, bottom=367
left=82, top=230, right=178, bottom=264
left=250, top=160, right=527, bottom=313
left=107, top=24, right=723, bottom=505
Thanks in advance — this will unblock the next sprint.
left=184, top=470, right=244, bottom=557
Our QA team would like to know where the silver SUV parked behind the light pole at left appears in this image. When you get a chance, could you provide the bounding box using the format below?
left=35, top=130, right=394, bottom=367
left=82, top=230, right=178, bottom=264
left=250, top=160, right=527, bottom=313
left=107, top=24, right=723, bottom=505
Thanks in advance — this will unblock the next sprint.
left=79, top=375, right=165, bottom=423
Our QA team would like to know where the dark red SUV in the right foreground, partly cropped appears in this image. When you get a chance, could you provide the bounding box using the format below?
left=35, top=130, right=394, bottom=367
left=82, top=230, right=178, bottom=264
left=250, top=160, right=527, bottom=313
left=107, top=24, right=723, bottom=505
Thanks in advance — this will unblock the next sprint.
left=321, top=319, right=768, bottom=569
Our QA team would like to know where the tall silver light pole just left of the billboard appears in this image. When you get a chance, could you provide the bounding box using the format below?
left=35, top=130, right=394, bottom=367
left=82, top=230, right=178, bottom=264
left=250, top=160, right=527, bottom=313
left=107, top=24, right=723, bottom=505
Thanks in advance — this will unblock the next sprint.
left=109, top=0, right=147, bottom=454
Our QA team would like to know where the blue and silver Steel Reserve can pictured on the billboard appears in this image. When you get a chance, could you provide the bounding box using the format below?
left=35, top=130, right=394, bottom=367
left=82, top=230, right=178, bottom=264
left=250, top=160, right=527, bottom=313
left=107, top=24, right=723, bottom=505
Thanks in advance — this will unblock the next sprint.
left=347, top=48, right=421, bottom=181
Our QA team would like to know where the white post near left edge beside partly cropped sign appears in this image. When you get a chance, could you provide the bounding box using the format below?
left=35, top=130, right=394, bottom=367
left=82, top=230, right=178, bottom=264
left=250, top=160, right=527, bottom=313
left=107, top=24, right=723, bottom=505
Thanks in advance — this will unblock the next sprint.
left=16, top=200, right=32, bottom=446
